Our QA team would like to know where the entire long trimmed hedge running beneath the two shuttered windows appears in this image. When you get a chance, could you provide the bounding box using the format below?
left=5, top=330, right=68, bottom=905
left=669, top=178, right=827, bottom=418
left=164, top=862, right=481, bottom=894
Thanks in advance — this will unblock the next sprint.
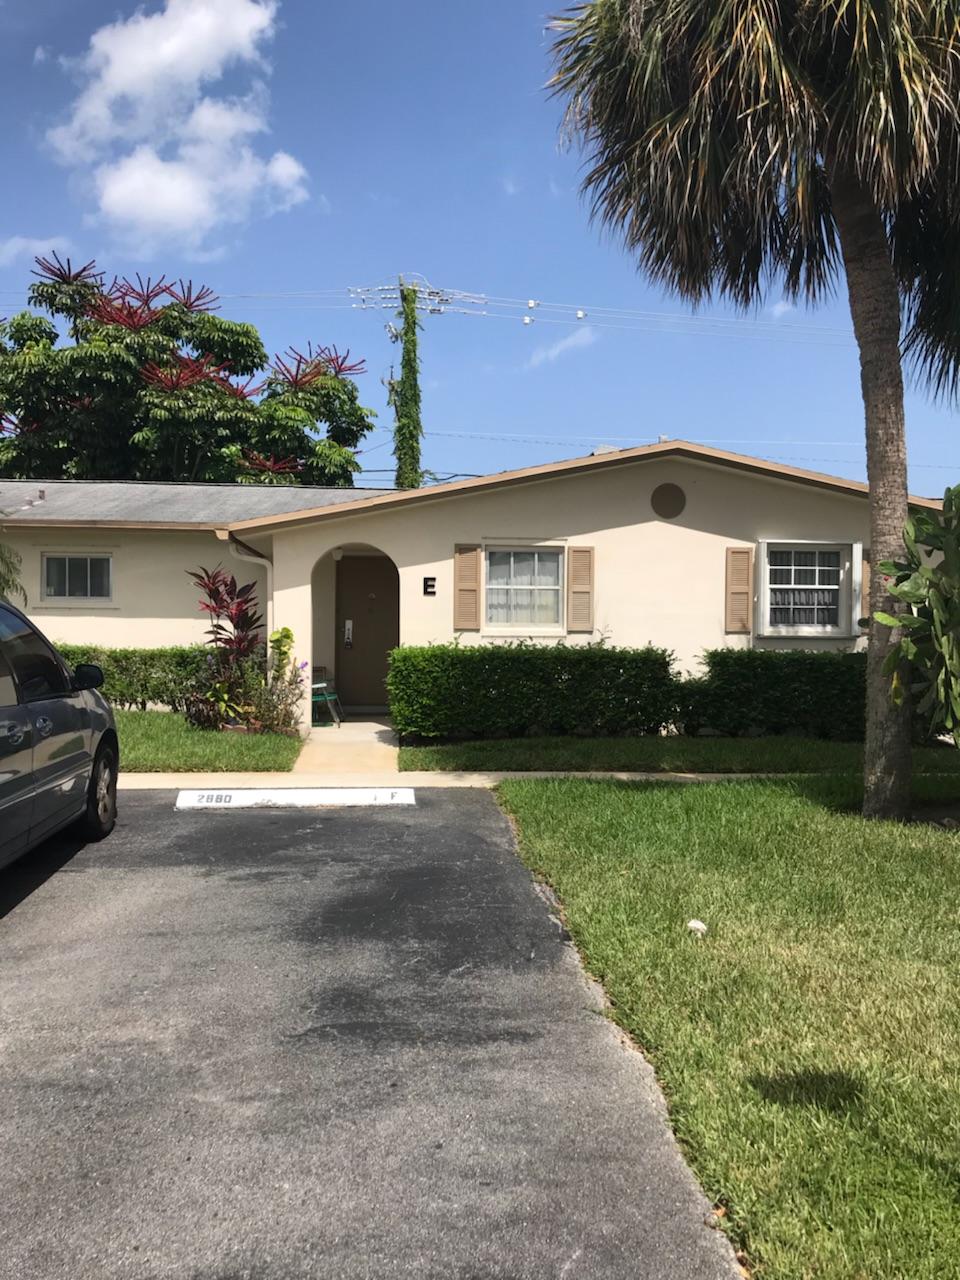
left=387, top=644, right=867, bottom=741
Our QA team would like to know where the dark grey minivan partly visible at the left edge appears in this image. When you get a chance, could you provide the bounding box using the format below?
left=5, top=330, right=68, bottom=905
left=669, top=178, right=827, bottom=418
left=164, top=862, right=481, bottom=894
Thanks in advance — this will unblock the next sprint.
left=0, top=600, right=119, bottom=867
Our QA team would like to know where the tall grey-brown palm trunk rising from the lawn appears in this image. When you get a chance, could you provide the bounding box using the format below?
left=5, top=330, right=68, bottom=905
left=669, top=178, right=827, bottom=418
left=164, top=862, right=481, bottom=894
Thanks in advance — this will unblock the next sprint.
left=831, top=170, right=911, bottom=818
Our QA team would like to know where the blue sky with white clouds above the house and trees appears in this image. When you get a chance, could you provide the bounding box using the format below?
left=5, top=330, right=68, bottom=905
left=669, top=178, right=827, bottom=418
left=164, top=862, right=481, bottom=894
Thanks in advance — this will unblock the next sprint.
left=0, top=0, right=960, bottom=494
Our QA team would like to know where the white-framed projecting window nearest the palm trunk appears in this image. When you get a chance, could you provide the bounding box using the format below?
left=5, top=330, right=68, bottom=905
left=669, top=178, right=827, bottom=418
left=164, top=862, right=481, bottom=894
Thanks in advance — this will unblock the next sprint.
left=760, top=543, right=859, bottom=635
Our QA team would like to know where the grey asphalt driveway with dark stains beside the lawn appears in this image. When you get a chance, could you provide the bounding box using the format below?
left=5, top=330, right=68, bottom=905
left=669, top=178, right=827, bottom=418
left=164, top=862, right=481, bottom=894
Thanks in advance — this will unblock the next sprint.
left=0, top=791, right=736, bottom=1280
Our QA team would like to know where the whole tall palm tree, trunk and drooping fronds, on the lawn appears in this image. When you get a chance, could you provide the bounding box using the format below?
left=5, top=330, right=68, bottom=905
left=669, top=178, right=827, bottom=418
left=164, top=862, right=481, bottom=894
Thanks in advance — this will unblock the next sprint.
left=553, top=0, right=960, bottom=817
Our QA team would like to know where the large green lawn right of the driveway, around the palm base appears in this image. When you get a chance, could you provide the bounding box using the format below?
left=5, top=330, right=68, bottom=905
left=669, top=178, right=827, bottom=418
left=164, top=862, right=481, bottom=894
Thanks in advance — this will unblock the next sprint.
left=498, top=777, right=960, bottom=1280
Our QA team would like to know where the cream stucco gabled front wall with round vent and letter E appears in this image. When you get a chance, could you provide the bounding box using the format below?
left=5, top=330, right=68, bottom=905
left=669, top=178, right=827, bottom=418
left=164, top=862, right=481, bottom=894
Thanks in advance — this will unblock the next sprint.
left=267, top=458, right=869, bottom=721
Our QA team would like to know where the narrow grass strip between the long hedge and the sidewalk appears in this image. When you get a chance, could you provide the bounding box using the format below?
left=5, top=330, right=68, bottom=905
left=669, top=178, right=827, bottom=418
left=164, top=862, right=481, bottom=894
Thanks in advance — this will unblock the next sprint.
left=399, top=737, right=960, bottom=773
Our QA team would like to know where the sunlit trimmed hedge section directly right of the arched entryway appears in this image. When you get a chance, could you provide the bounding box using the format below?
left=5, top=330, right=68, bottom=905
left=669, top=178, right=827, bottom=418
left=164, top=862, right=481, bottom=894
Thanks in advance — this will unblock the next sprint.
left=387, top=644, right=677, bottom=739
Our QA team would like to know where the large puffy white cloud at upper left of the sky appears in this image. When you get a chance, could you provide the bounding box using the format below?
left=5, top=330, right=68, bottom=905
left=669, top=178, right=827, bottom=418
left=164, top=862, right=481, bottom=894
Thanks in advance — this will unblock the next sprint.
left=47, top=0, right=312, bottom=256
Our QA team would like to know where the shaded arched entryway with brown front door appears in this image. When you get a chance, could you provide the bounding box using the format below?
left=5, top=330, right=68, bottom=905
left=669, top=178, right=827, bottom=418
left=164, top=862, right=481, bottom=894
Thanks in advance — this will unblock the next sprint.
left=312, top=543, right=399, bottom=712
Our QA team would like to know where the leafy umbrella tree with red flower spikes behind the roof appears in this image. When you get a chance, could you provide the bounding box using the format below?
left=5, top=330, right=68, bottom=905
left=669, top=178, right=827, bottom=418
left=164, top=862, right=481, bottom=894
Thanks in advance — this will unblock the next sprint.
left=0, top=255, right=374, bottom=486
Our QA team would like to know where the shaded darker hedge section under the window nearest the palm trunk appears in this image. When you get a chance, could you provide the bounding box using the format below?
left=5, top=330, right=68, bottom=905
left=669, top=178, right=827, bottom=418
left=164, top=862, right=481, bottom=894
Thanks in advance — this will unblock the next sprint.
left=677, top=649, right=867, bottom=741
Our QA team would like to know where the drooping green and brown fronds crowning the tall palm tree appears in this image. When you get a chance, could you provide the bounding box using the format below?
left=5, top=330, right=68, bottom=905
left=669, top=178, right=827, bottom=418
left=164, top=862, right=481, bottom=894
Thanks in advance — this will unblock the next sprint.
left=552, top=0, right=960, bottom=345
